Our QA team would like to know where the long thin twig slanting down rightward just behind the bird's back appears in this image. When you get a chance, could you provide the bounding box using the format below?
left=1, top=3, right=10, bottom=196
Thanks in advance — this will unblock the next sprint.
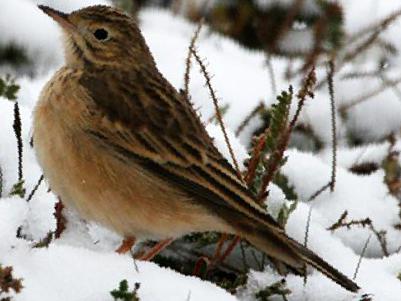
left=191, top=48, right=242, bottom=180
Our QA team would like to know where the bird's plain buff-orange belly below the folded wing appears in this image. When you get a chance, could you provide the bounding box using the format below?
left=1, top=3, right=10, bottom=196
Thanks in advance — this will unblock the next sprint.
left=34, top=101, right=227, bottom=238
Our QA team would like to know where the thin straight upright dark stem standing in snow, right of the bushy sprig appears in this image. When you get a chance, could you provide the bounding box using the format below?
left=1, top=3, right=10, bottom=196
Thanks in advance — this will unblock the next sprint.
left=327, top=58, right=337, bottom=192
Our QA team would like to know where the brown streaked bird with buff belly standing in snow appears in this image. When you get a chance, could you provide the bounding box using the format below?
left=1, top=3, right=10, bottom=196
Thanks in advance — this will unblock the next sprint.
left=33, top=5, right=359, bottom=292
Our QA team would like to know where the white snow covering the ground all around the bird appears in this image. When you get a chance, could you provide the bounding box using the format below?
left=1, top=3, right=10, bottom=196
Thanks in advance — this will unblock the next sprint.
left=0, top=0, right=401, bottom=301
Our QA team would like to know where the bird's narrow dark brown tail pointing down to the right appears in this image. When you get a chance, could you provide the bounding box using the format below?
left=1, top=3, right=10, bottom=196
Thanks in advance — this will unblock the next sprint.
left=241, top=222, right=359, bottom=292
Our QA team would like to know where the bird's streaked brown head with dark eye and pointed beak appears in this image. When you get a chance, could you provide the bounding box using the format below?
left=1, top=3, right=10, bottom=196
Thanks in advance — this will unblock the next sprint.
left=39, top=5, right=154, bottom=69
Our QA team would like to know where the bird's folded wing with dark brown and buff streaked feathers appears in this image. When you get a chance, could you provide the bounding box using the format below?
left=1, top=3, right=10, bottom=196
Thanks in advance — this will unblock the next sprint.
left=80, top=72, right=282, bottom=232
